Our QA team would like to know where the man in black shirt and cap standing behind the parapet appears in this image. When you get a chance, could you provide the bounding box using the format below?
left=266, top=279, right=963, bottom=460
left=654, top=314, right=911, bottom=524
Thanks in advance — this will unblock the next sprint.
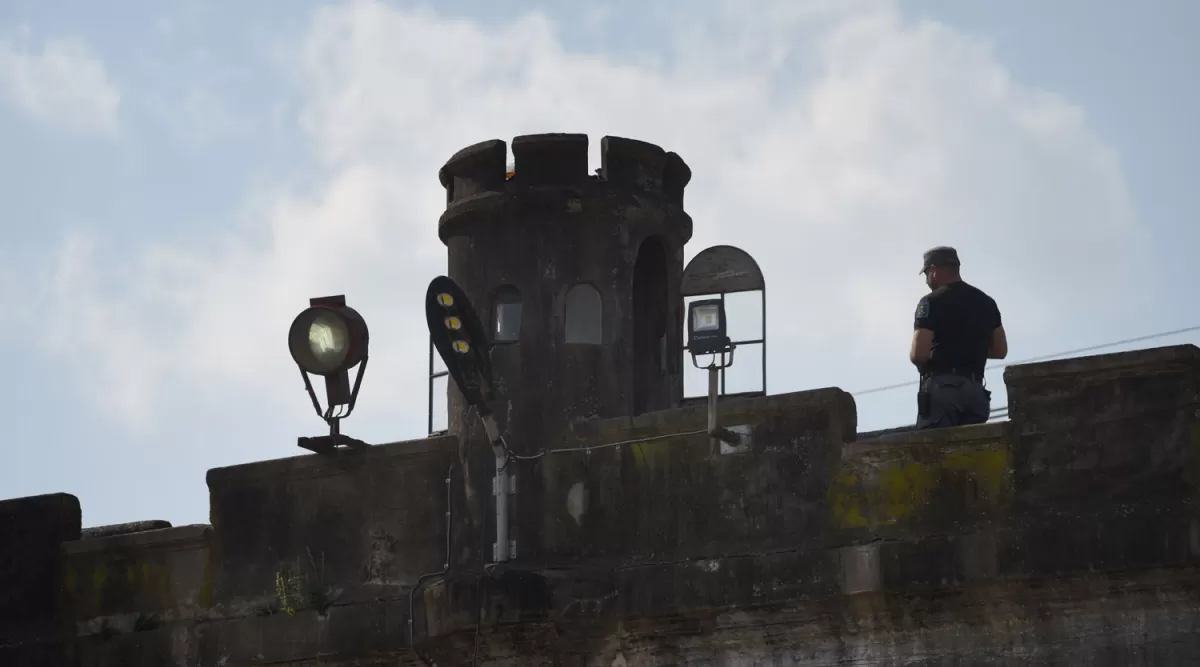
left=908, top=246, right=1008, bottom=428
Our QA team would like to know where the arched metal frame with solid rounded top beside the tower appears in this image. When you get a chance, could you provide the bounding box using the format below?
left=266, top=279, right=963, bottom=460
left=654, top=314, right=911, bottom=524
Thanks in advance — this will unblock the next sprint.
left=679, top=246, right=767, bottom=403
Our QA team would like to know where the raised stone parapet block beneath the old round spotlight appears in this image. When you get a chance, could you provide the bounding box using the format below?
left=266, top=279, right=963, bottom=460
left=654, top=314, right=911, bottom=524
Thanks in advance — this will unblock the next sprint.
left=208, top=437, right=458, bottom=608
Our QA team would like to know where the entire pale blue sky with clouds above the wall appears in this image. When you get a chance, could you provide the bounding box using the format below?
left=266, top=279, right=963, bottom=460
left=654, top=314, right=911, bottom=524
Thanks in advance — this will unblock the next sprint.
left=0, top=0, right=1200, bottom=525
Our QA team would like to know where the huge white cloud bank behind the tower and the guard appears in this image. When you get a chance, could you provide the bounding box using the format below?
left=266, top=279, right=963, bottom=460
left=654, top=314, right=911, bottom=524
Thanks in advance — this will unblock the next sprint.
left=23, top=1, right=1139, bottom=443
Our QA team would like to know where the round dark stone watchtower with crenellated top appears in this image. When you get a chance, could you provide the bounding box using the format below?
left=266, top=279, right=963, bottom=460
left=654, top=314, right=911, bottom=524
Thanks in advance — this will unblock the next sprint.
left=438, top=134, right=692, bottom=563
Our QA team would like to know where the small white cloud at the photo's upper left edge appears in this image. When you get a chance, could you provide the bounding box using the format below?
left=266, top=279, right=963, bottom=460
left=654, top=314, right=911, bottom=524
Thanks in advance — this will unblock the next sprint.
left=0, top=32, right=121, bottom=133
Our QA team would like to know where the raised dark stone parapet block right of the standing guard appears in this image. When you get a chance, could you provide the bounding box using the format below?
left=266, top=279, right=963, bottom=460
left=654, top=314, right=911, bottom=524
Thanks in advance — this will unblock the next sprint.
left=1004, top=345, right=1200, bottom=513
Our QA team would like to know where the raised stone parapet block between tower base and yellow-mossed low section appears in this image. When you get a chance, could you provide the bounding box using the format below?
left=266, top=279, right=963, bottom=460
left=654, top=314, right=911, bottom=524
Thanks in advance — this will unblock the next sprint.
left=544, top=389, right=854, bottom=561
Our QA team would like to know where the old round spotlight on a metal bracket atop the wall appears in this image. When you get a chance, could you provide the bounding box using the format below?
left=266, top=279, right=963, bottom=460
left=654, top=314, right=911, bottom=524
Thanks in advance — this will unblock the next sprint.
left=288, top=295, right=370, bottom=453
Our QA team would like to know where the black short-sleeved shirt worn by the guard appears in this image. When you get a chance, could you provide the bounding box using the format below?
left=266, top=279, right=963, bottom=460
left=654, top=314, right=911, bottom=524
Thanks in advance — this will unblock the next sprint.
left=913, top=281, right=1001, bottom=378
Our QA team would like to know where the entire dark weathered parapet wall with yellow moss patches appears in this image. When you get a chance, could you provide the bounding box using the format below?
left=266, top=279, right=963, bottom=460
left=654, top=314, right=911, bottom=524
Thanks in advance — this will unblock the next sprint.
left=0, top=345, right=1200, bottom=667
